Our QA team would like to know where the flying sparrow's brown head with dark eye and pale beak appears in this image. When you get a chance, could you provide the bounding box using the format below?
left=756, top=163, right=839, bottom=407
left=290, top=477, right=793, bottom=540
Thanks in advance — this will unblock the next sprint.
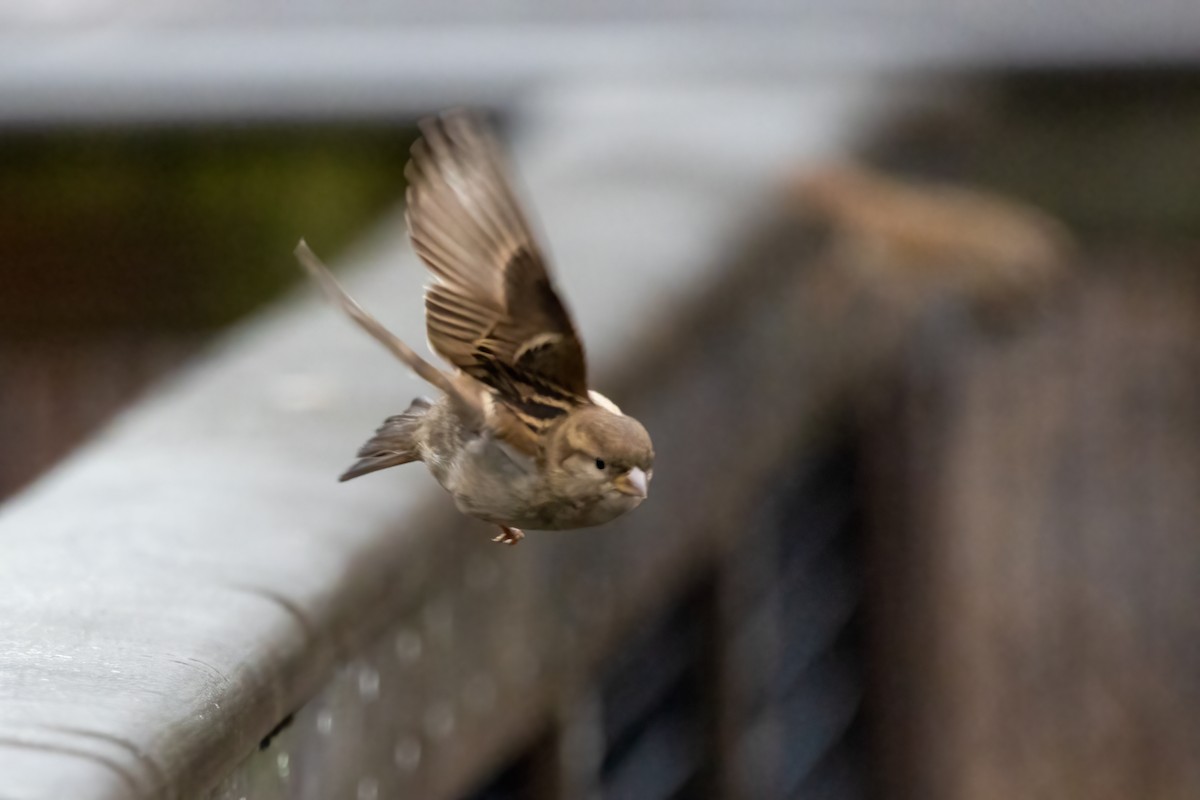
left=550, top=405, right=654, bottom=511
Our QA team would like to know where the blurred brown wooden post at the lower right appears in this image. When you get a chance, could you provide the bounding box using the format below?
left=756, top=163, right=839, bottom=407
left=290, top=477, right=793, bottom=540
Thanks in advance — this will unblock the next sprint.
left=871, top=255, right=1200, bottom=800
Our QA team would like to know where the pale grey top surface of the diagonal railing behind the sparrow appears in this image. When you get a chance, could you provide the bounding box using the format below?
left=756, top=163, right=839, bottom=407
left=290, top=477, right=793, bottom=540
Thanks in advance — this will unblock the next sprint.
left=0, top=80, right=869, bottom=800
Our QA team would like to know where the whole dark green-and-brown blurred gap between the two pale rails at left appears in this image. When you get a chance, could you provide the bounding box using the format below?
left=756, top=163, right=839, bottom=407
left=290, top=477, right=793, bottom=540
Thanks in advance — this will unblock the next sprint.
left=0, top=121, right=413, bottom=499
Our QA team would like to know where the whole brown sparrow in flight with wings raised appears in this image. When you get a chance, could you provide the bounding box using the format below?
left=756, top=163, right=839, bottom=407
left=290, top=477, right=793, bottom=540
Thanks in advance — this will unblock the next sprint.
left=295, top=112, right=654, bottom=545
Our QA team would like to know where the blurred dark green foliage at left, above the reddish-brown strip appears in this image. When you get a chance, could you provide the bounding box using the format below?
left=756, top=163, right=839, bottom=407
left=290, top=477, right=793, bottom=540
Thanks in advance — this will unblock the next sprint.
left=0, top=125, right=415, bottom=337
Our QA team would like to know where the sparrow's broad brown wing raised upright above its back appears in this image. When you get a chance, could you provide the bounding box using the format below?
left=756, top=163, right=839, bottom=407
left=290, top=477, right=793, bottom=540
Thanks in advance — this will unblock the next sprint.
left=406, top=112, right=589, bottom=441
